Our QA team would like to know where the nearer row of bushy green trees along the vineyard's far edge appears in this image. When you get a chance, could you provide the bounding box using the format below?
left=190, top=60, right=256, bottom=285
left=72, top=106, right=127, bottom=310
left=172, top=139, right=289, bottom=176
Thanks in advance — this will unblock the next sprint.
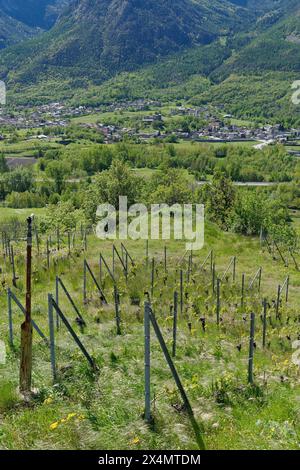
left=39, top=160, right=298, bottom=255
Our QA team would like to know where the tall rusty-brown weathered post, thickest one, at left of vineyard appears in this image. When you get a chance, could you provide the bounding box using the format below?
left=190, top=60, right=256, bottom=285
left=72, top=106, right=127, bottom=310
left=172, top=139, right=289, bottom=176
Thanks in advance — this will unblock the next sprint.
left=20, top=217, right=32, bottom=395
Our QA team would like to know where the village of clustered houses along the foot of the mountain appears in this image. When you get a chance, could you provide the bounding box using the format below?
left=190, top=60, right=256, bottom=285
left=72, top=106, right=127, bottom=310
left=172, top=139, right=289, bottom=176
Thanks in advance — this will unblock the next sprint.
left=0, top=100, right=300, bottom=149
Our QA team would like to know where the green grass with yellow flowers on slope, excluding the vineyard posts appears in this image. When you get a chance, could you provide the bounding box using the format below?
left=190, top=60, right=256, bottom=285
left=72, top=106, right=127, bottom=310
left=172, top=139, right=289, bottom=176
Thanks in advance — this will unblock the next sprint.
left=0, top=215, right=300, bottom=449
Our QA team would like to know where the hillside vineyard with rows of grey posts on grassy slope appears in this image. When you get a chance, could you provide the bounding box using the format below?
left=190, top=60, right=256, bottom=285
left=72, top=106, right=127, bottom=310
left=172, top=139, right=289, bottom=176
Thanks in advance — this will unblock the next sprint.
left=0, top=218, right=300, bottom=449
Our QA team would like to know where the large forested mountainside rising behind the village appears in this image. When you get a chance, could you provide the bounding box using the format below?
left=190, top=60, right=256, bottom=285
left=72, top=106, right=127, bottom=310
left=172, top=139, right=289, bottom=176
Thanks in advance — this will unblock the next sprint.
left=0, top=0, right=300, bottom=125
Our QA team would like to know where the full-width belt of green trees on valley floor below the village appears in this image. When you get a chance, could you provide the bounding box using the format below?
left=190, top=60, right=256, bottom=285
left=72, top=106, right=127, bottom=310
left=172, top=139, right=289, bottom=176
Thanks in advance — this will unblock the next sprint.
left=0, top=143, right=300, bottom=216
